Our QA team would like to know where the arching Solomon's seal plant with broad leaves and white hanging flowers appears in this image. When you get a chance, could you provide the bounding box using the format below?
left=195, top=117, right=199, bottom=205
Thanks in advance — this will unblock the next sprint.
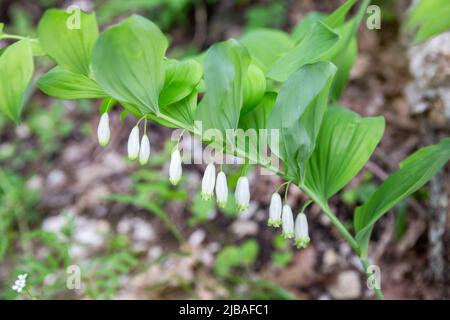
left=0, top=0, right=450, bottom=298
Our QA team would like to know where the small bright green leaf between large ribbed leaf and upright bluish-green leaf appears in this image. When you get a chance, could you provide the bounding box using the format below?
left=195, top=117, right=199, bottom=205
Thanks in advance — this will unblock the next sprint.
left=159, top=60, right=203, bottom=108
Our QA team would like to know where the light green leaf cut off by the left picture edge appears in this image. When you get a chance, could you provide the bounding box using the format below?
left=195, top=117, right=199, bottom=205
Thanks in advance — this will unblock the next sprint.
left=0, top=39, right=34, bottom=124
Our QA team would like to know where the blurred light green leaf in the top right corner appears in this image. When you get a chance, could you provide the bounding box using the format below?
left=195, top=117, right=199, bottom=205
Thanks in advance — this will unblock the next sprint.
left=404, top=0, right=450, bottom=43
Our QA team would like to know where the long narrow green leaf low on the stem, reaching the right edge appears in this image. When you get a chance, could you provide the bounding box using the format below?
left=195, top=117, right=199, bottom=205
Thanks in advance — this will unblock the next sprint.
left=354, top=138, right=450, bottom=255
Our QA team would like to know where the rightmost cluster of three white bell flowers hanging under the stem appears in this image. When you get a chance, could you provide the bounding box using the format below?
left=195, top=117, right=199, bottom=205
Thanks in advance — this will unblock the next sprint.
left=267, top=182, right=311, bottom=248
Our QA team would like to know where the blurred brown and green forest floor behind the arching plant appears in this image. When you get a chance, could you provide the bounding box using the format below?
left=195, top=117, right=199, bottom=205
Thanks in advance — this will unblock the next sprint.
left=0, top=0, right=450, bottom=299
